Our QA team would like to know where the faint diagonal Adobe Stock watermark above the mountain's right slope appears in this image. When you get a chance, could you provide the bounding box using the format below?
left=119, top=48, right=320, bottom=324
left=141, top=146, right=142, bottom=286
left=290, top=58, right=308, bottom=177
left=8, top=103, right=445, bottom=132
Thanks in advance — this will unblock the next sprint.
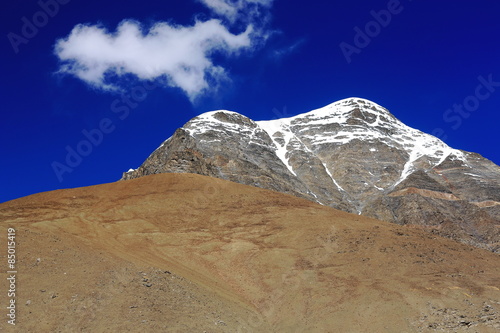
left=431, top=74, right=500, bottom=140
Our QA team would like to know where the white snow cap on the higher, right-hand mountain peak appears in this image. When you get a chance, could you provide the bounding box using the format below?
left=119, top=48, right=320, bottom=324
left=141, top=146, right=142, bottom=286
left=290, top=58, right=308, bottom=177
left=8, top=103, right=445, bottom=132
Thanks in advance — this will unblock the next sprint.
left=257, top=98, right=465, bottom=186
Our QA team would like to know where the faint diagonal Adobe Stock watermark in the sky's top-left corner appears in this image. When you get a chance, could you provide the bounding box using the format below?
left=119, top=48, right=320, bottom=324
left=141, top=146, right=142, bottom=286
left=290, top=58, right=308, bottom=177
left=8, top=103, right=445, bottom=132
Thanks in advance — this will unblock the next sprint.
left=7, top=0, right=71, bottom=54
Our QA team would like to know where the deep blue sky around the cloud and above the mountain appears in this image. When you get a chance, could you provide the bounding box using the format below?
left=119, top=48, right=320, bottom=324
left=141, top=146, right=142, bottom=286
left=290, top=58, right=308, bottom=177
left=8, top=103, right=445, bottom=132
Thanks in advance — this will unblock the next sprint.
left=0, top=0, right=500, bottom=202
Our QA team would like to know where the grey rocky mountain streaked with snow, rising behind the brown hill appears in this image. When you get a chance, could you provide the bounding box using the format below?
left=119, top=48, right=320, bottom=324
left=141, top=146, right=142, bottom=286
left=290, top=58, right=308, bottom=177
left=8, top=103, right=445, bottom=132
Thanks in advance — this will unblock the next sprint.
left=122, top=98, right=500, bottom=252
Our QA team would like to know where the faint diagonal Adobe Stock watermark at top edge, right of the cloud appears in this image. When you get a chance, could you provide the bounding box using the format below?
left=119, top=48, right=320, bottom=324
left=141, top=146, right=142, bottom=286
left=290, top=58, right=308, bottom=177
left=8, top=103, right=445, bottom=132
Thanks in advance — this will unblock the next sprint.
left=339, top=0, right=412, bottom=64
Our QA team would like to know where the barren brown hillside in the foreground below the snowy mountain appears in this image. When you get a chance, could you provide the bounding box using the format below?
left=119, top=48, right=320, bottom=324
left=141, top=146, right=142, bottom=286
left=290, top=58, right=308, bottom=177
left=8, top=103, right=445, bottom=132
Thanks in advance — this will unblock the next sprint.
left=0, top=174, right=500, bottom=333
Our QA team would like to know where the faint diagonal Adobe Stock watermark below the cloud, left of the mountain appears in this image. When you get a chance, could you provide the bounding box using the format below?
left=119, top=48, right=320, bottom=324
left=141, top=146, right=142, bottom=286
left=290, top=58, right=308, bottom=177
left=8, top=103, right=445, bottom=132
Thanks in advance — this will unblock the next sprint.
left=51, top=82, right=158, bottom=183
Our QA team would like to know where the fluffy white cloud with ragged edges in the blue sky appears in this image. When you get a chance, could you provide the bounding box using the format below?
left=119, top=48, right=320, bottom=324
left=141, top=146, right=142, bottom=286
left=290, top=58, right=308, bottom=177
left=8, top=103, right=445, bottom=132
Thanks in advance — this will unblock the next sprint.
left=55, top=0, right=272, bottom=102
